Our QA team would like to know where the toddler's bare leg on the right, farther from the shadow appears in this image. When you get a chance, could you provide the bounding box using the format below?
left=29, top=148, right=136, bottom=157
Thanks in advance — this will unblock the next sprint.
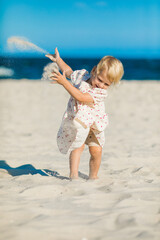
left=89, top=146, right=102, bottom=179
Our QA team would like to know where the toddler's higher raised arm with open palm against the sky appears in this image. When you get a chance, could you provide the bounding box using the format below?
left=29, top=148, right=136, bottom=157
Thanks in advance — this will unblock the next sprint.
left=46, top=48, right=73, bottom=78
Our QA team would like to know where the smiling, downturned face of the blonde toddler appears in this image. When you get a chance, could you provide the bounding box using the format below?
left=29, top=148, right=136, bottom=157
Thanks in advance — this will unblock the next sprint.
left=90, top=71, right=111, bottom=89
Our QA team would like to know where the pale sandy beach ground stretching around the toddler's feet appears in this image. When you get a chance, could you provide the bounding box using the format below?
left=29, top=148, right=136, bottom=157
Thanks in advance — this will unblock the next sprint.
left=0, top=79, right=160, bottom=240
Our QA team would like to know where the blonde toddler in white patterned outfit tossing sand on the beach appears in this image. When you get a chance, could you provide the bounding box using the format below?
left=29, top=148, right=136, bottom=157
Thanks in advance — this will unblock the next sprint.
left=46, top=48, right=124, bottom=179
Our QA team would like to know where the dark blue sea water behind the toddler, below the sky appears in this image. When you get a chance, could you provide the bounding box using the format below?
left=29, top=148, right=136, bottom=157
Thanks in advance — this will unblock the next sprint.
left=0, top=57, right=160, bottom=80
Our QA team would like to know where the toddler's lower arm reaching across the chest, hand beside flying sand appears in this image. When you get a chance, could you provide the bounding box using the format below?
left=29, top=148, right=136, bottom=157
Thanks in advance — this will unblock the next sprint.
left=51, top=72, right=94, bottom=103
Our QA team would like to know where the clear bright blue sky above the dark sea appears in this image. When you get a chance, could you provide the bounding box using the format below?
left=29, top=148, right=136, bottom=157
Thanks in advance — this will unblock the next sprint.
left=0, top=0, right=160, bottom=58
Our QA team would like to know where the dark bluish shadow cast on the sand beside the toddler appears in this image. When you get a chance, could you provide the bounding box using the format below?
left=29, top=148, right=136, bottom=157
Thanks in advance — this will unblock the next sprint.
left=0, top=160, right=70, bottom=180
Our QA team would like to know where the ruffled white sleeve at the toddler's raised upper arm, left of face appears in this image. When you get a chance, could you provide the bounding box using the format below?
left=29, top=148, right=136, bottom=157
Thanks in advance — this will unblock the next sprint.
left=71, top=69, right=90, bottom=86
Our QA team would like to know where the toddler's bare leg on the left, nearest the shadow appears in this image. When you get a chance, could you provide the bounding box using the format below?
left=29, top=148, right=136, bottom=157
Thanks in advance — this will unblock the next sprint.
left=69, top=144, right=85, bottom=179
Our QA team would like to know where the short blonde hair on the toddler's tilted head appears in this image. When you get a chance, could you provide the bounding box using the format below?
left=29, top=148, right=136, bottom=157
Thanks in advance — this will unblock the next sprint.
left=95, top=56, right=124, bottom=84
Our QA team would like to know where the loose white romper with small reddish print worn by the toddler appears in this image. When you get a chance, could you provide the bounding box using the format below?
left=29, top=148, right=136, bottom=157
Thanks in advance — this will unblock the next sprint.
left=57, top=69, right=108, bottom=154
